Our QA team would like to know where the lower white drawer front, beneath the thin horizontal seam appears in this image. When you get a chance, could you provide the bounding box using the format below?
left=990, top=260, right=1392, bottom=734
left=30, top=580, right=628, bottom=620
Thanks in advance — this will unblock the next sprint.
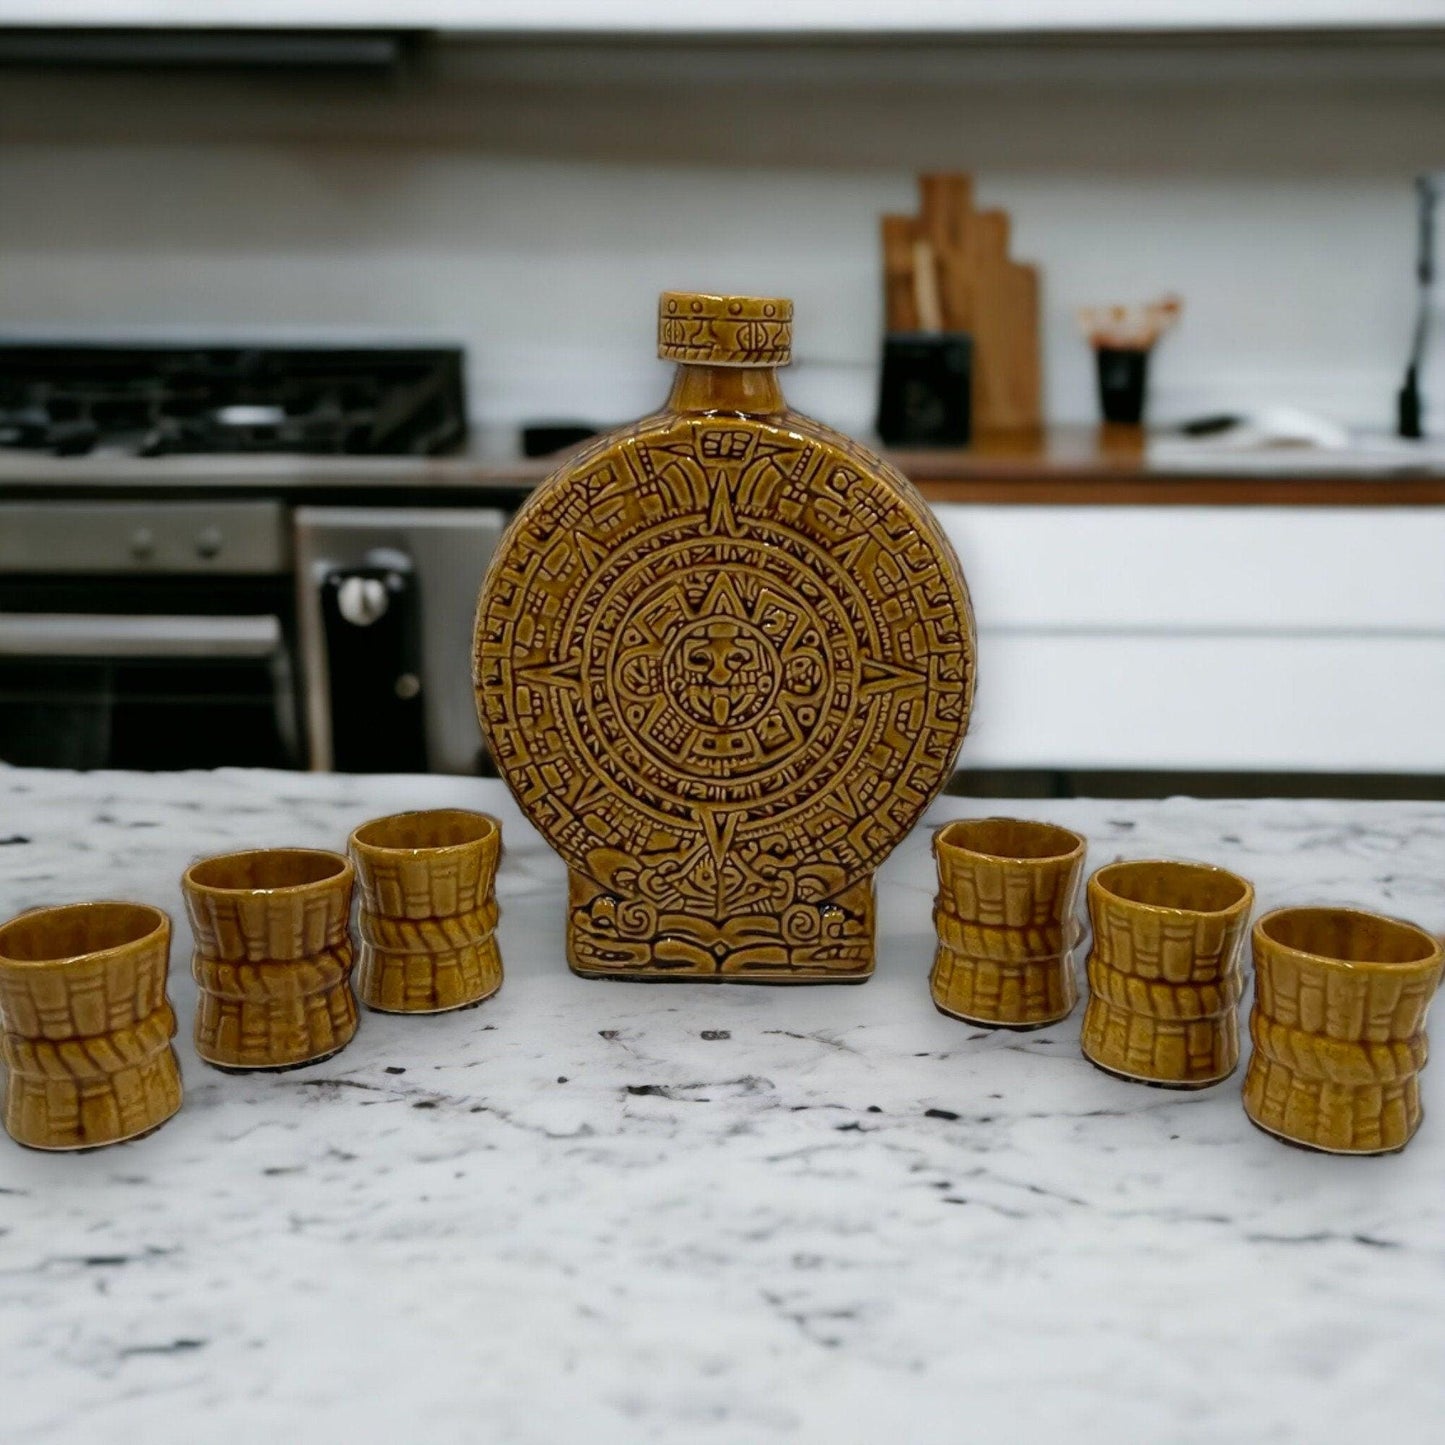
left=959, top=631, right=1445, bottom=773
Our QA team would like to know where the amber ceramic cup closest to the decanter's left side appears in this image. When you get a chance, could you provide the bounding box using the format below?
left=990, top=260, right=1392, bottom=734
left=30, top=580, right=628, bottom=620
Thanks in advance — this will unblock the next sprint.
left=350, top=808, right=501, bottom=1013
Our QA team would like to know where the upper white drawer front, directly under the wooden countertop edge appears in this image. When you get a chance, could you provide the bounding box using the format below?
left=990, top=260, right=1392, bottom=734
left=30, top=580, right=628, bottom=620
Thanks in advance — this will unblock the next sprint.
left=935, top=503, right=1445, bottom=634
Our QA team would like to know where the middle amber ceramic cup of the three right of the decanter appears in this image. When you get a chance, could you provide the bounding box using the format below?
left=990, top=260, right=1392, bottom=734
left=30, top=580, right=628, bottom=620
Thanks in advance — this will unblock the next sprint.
left=1081, top=860, right=1254, bottom=1088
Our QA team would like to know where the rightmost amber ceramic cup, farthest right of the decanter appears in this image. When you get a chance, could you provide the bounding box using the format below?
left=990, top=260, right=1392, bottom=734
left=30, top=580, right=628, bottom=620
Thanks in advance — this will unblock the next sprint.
left=1244, top=907, right=1442, bottom=1155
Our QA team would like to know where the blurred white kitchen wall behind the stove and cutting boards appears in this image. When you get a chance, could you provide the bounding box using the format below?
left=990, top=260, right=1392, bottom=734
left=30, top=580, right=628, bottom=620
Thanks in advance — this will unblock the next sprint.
left=0, top=39, right=1445, bottom=442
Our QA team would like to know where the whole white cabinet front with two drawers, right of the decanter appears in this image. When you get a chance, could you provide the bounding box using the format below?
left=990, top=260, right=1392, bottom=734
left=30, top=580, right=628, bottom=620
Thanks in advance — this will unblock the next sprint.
left=936, top=503, right=1445, bottom=773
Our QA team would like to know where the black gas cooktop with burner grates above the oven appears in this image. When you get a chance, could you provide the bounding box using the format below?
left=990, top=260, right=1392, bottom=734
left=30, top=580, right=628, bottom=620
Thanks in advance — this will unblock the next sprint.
left=0, top=344, right=467, bottom=457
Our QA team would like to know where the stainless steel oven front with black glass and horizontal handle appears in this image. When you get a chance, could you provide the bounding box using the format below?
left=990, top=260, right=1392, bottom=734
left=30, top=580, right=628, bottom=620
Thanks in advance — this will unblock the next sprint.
left=0, top=501, right=305, bottom=769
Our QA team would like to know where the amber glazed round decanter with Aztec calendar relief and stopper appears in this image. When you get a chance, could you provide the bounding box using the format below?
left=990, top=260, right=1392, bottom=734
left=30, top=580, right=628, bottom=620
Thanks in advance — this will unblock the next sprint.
left=474, top=292, right=974, bottom=983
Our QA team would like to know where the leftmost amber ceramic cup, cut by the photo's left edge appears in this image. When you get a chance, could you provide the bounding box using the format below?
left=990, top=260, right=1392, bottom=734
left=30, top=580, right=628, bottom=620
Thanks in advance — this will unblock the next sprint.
left=0, top=903, right=181, bottom=1149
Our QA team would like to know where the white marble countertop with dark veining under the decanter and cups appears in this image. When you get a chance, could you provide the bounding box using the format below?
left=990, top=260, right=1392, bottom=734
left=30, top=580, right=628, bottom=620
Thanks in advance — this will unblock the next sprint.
left=0, top=769, right=1445, bottom=1445
